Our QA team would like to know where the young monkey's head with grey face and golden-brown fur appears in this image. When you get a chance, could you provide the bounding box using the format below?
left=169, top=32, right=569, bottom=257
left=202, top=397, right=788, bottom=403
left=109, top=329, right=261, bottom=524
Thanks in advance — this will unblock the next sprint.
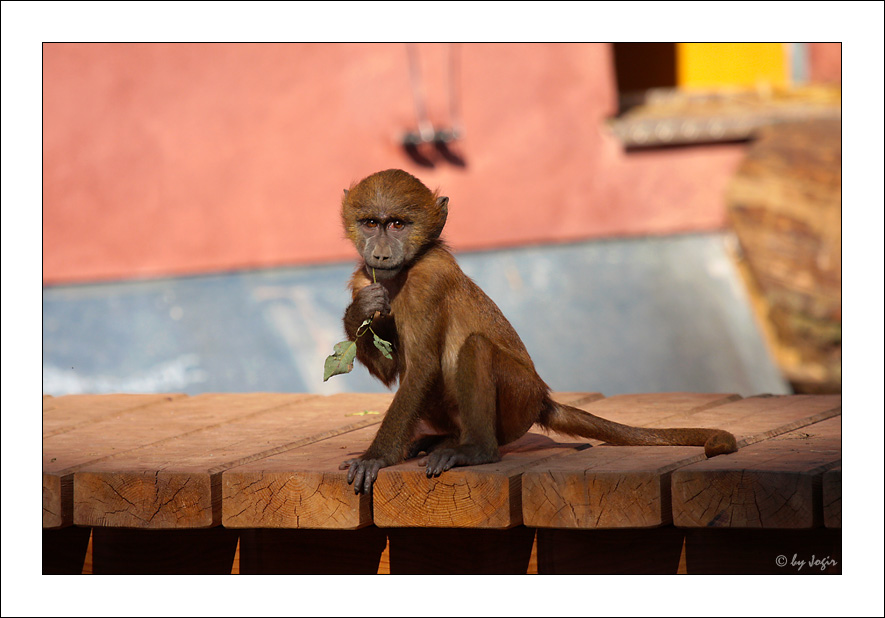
left=341, top=170, right=449, bottom=280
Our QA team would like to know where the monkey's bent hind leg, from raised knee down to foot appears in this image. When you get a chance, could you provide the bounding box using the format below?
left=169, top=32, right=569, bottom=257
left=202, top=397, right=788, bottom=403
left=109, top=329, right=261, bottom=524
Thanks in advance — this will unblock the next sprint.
left=427, top=334, right=501, bottom=478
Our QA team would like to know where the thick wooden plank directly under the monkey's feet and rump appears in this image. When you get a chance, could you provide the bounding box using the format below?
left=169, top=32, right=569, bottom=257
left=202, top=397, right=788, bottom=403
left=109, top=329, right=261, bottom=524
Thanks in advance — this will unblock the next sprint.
left=374, top=393, right=600, bottom=529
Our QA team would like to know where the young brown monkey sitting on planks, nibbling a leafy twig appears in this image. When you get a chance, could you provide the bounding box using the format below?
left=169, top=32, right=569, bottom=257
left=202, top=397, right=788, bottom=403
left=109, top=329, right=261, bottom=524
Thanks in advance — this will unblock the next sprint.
left=339, top=169, right=737, bottom=494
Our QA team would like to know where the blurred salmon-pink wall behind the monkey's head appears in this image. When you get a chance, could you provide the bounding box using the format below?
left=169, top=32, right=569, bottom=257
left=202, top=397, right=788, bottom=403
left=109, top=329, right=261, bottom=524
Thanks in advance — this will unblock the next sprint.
left=43, top=44, right=743, bottom=284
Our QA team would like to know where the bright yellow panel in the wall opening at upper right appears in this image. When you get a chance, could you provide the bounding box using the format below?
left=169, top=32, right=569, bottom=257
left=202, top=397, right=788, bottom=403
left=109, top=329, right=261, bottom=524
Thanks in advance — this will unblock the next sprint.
left=676, top=43, right=789, bottom=88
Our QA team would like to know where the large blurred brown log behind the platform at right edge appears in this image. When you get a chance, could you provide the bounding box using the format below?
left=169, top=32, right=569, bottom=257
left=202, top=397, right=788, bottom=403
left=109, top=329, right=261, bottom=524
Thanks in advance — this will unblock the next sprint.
left=726, top=119, right=842, bottom=393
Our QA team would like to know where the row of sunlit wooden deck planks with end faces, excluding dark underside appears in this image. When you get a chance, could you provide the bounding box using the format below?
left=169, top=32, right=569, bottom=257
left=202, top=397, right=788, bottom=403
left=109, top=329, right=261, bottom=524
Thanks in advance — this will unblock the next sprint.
left=43, top=393, right=841, bottom=540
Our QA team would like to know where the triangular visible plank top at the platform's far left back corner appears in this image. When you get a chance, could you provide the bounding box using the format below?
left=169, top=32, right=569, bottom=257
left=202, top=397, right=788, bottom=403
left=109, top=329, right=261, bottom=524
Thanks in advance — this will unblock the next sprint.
left=43, top=393, right=185, bottom=438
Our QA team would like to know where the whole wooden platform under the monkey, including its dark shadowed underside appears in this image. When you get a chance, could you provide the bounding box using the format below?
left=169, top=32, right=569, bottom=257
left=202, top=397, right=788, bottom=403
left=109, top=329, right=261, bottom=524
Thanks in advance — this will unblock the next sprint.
left=43, top=393, right=842, bottom=573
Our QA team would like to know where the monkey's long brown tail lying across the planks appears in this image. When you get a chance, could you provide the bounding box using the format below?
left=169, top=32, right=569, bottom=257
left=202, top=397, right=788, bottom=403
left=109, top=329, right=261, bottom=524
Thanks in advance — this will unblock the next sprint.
left=539, top=402, right=737, bottom=457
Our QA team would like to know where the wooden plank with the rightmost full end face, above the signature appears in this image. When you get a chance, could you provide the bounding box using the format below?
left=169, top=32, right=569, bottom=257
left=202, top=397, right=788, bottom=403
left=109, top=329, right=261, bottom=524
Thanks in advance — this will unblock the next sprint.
left=672, top=416, right=842, bottom=529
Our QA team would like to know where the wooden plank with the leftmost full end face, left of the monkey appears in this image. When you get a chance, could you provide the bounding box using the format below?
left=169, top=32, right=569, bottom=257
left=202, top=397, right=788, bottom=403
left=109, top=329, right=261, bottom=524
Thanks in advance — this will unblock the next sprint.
left=74, top=394, right=380, bottom=528
